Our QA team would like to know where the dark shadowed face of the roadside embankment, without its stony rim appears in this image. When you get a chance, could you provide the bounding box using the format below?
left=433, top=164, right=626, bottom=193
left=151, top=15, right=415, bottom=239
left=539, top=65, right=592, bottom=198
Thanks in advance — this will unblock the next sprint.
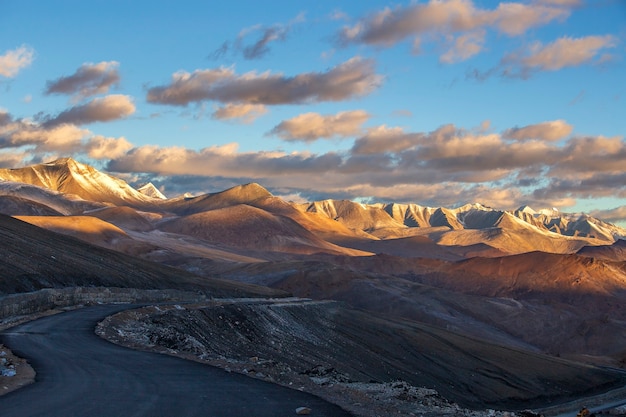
left=103, top=302, right=625, bottom=409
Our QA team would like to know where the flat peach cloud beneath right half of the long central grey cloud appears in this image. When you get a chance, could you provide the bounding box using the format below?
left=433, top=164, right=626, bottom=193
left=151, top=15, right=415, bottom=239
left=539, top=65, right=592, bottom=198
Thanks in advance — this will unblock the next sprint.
left=269, top=110, right=370, bottom=142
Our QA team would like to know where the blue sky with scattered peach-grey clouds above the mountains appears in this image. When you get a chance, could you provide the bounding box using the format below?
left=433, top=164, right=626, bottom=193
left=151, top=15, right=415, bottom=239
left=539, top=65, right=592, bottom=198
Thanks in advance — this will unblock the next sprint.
left=0, top=0, right=626, bottom=221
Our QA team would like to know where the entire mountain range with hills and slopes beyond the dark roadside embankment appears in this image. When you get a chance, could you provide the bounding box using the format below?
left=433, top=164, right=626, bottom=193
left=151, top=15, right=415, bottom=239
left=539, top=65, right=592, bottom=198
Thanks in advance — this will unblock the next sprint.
left=0, top=158, right=626, bottom=410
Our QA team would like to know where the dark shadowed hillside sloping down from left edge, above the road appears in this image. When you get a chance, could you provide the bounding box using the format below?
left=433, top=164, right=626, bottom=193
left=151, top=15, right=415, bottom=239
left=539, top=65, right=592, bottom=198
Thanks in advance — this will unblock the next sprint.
left=0, top=215, right=284, bottom=296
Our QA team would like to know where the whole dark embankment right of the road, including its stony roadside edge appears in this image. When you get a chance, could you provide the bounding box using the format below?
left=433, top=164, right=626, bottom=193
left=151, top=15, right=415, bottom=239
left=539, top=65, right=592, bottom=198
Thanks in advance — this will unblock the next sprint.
left=99, top=300, right=623, bottom=417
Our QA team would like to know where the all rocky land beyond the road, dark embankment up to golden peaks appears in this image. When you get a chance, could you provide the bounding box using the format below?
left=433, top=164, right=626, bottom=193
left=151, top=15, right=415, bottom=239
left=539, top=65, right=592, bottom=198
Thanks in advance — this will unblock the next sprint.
left=0, top=158, right=626, bottom=415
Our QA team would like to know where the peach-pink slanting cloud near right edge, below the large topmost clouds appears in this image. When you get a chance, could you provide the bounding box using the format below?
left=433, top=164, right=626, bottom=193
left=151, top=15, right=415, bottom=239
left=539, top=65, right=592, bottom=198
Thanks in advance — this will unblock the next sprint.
left=501, top=35, right=617, bottom=78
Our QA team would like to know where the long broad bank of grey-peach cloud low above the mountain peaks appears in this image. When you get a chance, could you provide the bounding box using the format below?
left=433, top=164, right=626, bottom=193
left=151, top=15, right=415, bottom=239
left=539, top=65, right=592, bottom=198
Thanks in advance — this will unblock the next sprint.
left=97, top=115, right=626, bottom=218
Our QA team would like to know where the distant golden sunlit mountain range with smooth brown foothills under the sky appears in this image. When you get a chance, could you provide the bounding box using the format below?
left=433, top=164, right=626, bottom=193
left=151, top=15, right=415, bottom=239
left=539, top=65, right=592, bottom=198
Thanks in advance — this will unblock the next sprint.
left=0, top=158, right=626, bottom=259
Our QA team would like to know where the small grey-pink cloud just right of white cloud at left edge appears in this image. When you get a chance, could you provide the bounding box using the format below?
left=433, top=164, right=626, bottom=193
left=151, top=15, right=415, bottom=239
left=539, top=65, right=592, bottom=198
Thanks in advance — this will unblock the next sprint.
left=45, top=61, right=120, bottom=99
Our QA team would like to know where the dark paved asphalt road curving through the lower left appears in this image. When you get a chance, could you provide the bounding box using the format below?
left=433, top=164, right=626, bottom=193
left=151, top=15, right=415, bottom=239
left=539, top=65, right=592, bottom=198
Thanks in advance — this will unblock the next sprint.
left=0, top=305, right=350, bottom=417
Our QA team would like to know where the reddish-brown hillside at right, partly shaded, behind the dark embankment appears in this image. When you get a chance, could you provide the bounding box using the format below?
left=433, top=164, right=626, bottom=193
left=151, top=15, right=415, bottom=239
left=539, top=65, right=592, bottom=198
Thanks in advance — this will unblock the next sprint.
left=207, top=253, right=626, bottom=367
